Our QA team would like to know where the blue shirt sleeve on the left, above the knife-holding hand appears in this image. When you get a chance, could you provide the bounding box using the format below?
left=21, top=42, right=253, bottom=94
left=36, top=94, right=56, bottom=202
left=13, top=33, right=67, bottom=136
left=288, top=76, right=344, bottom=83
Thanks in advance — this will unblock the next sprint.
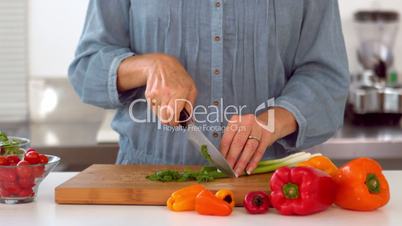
left=68, top=0, right=137, bottom=108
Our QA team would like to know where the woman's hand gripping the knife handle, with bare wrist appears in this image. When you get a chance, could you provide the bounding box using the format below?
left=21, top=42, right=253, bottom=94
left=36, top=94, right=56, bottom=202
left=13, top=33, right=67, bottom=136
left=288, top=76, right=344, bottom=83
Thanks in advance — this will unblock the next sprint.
left=117, top=53, right=197, bottom=126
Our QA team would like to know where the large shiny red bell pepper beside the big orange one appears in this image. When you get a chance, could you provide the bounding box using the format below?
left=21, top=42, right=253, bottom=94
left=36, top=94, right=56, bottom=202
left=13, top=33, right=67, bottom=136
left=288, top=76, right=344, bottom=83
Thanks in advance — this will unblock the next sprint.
left=270, top=167, right=336, bottom=215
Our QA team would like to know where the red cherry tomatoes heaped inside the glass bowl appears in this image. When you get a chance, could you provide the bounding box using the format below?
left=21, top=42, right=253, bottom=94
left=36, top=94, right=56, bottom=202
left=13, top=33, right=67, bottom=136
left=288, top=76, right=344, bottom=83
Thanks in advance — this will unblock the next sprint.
left=0, top=148, right=48, bottom=198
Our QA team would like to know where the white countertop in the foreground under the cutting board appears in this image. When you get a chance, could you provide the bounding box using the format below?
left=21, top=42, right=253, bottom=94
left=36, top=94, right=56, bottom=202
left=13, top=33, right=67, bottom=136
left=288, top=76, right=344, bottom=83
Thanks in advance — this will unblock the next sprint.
left=0, top=171, right=402, bottom=226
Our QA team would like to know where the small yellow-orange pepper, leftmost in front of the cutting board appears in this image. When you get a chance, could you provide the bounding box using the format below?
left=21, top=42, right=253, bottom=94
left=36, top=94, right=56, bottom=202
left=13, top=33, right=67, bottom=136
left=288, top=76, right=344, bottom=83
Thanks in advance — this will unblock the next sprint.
left=166, top=184, right=205, bottom=211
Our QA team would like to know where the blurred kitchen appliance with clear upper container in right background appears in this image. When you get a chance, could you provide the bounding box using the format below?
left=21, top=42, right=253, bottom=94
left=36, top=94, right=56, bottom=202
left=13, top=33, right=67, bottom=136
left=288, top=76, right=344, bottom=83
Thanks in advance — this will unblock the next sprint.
left=348, top=11, right=402, bottom=123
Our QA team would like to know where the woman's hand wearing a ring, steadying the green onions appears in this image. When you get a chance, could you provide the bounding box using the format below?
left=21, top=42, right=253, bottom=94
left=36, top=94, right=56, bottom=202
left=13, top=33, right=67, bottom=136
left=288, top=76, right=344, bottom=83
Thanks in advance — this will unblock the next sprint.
left=220, top=108, right=297, bottom=176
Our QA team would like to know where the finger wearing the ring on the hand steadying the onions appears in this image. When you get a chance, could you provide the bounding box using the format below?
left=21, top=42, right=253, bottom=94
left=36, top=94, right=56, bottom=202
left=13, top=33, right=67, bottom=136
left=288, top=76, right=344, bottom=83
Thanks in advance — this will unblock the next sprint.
left=234, top=126, right=261, bottom=175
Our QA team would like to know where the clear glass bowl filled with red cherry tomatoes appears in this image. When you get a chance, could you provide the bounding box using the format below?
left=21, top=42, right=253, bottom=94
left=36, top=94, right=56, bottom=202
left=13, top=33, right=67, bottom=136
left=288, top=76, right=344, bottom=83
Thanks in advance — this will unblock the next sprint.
left=0, top=148, right=60, bottom=204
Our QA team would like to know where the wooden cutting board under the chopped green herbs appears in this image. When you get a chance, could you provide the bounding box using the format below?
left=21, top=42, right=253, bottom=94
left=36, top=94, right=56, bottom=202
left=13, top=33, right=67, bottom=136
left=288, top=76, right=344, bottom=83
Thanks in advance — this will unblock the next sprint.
left=55, top=165, right=271, bottom=206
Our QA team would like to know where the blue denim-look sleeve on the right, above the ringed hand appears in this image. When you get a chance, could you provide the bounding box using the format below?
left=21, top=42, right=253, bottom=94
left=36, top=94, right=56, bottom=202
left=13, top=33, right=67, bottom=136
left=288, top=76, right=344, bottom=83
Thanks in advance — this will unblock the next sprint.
left=275, top=0, right=350, bottom=151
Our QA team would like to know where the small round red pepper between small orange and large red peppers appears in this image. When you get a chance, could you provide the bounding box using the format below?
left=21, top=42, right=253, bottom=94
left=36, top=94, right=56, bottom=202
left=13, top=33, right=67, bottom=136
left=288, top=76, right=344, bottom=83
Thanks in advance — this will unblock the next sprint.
left=243, top=191, right=269, bottom=214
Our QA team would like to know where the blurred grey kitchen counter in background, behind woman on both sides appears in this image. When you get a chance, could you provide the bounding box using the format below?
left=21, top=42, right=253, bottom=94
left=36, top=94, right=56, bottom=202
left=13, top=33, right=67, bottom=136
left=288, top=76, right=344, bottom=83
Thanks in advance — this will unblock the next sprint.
left=0, top=117, right=402, bottom=171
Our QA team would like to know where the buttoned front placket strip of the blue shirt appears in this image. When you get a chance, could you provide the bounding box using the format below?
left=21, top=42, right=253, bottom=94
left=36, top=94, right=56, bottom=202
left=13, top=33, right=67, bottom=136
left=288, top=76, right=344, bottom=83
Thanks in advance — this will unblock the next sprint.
left=210, top=0, right=223, bottom=146
